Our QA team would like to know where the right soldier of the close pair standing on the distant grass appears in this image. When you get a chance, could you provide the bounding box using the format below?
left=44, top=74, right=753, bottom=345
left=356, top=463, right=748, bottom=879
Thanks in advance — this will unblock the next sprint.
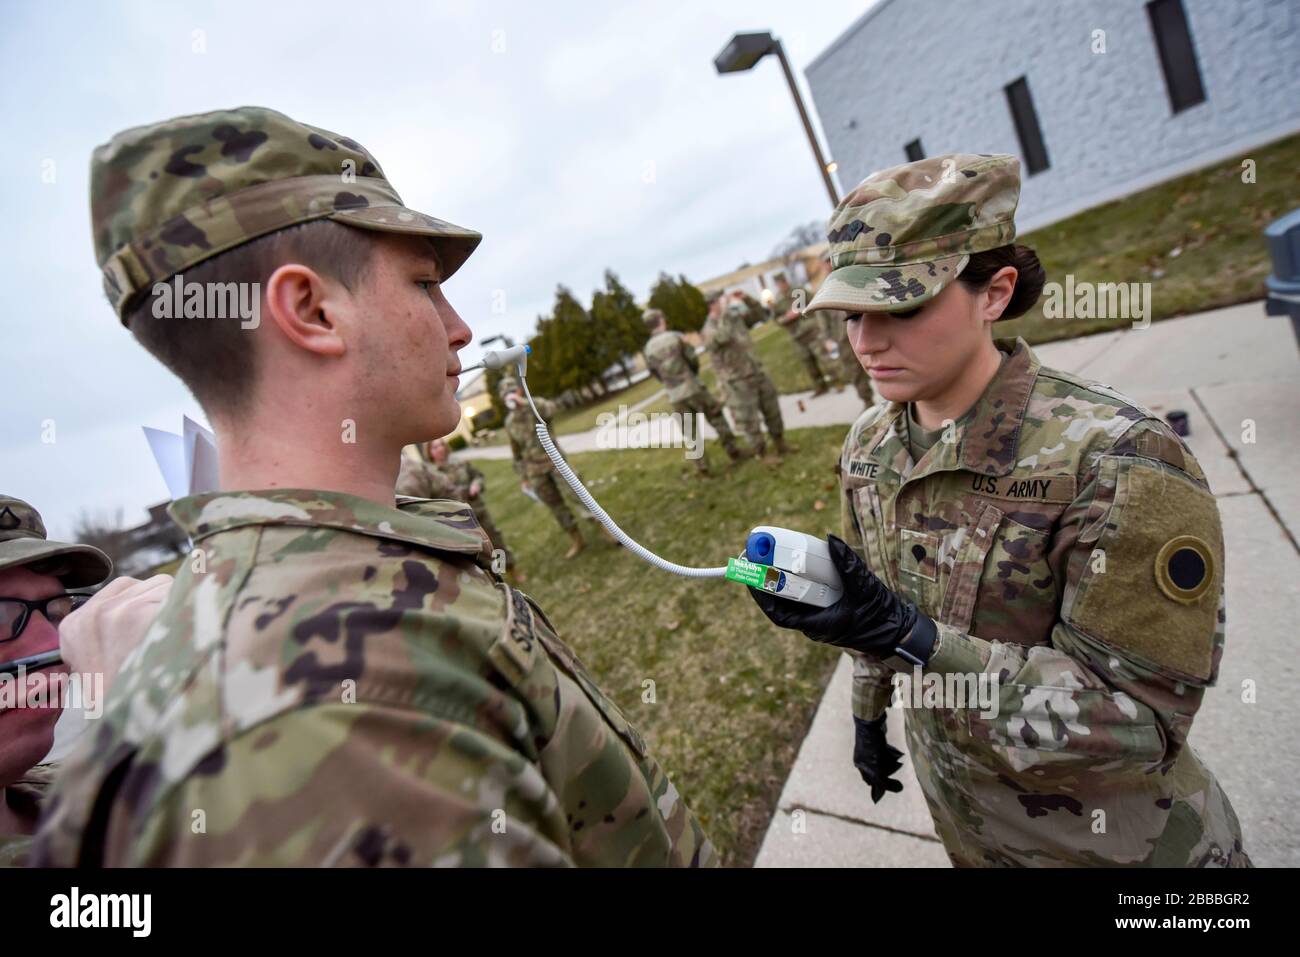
left=701, top=293, right=797, bottom=463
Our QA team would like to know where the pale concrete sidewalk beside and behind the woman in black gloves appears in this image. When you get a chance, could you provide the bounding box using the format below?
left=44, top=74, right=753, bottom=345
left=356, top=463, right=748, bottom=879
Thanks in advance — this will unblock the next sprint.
left=755, top=303, right=1300, bottom=867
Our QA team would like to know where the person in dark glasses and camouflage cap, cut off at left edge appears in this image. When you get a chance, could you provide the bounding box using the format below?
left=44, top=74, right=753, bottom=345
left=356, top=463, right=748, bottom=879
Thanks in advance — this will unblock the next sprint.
left=0, top=495, right=113, bottom=867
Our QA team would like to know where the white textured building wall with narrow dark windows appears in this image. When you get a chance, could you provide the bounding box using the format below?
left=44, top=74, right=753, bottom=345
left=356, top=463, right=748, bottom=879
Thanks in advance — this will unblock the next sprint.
left=806, top=0, right=1300, bottom=231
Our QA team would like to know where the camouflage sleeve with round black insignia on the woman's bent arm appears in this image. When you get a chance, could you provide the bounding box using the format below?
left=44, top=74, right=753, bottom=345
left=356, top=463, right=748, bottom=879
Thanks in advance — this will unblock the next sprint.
left=927, top=420, right=1225, bottom=774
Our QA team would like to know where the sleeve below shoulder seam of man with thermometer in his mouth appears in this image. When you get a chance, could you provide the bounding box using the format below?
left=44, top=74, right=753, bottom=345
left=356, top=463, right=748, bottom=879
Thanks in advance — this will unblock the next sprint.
left=116, top=703, right=573, bottom=867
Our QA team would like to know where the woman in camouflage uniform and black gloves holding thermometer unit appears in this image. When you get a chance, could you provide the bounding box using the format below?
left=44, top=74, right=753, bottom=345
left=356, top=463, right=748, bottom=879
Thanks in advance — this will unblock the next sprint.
left=755, top=153, right=1249, bottom=867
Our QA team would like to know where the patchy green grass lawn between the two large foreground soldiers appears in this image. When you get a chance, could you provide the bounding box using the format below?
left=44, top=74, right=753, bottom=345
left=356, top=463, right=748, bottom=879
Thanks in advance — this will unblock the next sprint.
left=477, top=426, right=847, bottom=866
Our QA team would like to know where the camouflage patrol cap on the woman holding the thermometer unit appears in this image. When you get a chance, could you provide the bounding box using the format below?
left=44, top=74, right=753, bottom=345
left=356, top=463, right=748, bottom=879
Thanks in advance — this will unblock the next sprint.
left=805, top=153, right=1021, bottom=312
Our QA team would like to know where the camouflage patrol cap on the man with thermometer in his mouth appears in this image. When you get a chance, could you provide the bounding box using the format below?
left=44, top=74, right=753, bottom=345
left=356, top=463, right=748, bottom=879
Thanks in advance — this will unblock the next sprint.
left=90, top=107, right=482, bottom=321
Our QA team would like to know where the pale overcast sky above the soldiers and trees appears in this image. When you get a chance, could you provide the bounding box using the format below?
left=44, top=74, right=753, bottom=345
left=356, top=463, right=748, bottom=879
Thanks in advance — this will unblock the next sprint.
left=0, top=0, right=871, bottom=537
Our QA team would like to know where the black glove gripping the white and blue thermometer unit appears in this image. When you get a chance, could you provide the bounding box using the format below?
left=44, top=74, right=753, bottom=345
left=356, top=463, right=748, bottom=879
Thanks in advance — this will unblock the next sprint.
left=749, top=534, right=935, bottom=663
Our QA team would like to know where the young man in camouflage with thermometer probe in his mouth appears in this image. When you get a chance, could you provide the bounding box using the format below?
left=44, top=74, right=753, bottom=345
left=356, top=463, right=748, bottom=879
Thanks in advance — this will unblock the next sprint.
left=33, top=107, right=715, bottom=866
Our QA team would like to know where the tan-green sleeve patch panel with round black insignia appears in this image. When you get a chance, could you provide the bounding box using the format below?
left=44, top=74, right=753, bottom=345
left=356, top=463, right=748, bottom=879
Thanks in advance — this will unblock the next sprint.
left=1067, top=458, right=1223, bottom=683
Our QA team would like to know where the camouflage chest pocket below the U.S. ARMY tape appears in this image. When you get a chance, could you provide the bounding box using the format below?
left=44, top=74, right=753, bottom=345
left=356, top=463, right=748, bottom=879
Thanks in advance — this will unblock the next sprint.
left=944, top=503, right=1058, bottom=645
